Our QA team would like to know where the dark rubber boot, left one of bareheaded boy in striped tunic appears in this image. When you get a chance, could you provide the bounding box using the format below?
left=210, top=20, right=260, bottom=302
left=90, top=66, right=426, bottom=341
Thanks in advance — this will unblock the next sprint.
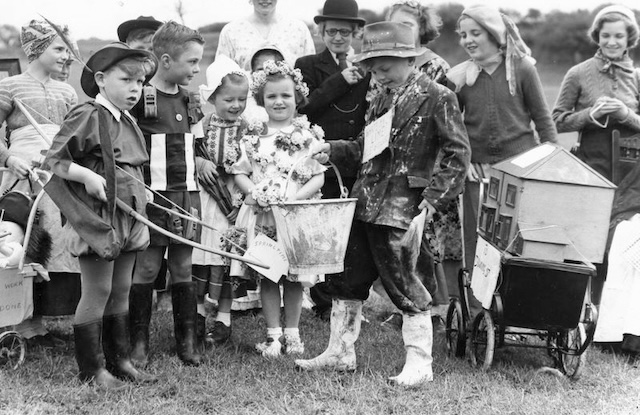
left=129, top=283, right=153, bottom=367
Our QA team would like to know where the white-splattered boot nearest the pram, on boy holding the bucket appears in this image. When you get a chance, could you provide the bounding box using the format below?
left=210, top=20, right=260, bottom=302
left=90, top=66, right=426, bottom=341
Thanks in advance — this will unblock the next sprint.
left=389, top=311, right=433, bottom=386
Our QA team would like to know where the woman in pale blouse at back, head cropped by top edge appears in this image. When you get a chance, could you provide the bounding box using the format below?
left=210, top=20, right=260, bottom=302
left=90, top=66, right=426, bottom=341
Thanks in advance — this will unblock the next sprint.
left=216, top=0, right=316, bottom=71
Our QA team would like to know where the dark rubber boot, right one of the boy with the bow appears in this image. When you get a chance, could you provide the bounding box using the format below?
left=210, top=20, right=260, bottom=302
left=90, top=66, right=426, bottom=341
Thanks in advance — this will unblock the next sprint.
left=102, top=313, right=157, bottom=383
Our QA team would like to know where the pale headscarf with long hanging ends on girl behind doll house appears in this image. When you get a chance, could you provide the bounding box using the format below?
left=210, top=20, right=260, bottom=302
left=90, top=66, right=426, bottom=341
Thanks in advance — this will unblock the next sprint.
left=447, top=6, right=536, bottom=95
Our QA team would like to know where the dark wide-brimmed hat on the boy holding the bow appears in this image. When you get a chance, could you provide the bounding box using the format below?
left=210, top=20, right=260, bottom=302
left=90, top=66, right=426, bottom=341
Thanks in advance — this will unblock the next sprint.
left=80, top=42, right=158, bottom=98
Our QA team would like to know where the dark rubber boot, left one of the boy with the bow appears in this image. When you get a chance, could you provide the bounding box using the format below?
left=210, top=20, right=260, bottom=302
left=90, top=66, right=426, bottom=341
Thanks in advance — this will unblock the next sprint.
left=73, top=319, right=126, bottom=390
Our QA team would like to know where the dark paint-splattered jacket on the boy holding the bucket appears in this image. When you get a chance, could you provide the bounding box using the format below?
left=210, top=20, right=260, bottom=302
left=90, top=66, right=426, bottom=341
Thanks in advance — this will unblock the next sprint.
left=331, top=72, right=471, bottom=229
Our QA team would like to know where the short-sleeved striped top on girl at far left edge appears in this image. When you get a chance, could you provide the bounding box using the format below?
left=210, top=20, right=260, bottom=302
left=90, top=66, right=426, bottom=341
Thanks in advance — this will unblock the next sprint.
left=0, top=72, right=78, bottom=166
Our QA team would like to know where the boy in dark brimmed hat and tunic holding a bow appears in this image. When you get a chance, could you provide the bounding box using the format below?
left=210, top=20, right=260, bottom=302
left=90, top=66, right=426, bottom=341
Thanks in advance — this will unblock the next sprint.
left=45, top=43, right=155, bottom=389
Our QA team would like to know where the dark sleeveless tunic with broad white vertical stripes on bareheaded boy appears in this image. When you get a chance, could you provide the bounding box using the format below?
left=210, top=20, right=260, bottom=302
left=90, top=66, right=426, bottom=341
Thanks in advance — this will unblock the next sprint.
left=132, top=88, right=202, bottom=192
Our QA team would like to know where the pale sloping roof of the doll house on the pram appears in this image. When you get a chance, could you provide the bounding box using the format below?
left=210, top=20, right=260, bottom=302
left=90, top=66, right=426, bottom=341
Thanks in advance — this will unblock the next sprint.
left=492, top=143, right=616, bottom=189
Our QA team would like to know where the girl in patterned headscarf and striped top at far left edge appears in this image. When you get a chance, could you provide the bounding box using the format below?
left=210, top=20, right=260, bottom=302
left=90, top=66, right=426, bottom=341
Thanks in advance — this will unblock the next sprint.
left=0, top=20, right=80, bottom=347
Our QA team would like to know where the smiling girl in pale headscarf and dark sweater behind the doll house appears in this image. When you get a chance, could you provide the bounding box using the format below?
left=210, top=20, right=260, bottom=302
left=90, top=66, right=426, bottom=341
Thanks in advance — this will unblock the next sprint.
left=447, top=6, right=556, bottom=314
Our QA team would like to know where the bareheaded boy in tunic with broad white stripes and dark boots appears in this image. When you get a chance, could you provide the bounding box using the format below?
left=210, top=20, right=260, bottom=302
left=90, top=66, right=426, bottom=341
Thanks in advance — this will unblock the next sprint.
left=129, top=21, right=204, bottom=365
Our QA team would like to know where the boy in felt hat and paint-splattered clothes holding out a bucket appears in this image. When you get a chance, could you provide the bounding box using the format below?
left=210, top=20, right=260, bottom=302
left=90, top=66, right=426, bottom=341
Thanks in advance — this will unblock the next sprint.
left=296, top=22, right=471, bottom=386
